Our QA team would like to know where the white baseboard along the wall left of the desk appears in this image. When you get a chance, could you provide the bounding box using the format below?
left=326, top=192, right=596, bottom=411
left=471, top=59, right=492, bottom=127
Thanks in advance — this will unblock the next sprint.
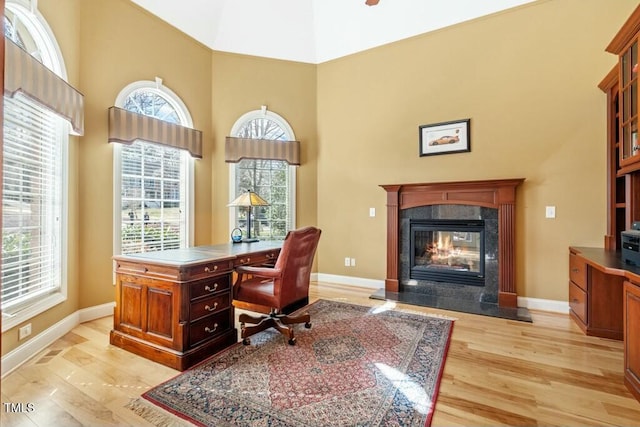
left=1, top=302, right=115, bottom=378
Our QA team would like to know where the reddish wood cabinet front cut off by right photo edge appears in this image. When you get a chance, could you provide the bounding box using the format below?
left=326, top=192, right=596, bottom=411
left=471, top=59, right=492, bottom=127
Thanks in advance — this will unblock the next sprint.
left=624, top=281, right=640, bottom=400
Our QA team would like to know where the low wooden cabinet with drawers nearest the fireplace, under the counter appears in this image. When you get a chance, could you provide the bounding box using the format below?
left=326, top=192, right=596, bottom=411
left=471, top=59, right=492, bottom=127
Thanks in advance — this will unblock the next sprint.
left=569, top=248, right=624, bottom=340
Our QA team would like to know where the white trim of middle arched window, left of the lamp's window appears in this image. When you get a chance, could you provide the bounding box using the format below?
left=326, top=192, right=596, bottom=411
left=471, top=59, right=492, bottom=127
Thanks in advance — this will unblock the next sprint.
left=112, top=77, right=195, bottom=262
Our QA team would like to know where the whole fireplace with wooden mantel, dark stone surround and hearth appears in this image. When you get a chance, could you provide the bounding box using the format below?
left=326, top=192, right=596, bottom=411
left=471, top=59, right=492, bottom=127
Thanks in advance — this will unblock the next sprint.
left=371, top=179, right=531, bottom=321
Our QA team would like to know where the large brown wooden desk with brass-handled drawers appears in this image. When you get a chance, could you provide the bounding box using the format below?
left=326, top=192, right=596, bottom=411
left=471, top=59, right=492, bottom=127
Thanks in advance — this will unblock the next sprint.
left=110, top=242, right=282, bottom=371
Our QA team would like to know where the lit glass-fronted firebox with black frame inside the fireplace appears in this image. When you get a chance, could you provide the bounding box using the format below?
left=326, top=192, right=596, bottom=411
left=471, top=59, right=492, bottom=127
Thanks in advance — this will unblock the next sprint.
left=408, top=219, right=485, bottom=286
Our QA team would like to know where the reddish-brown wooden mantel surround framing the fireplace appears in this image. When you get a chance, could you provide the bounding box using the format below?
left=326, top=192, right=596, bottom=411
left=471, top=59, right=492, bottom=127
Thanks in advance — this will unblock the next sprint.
left=381, top=178, right=524, bottom=308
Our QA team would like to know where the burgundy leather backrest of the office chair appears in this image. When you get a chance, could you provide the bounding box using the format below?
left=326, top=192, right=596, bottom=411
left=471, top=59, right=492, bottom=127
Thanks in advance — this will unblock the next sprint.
left=274, top=227, right=321, bottom=309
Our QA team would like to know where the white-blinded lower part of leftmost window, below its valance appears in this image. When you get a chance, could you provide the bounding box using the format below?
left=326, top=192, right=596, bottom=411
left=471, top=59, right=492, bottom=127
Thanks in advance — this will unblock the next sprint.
left=2, top=96, right=66, bottom=312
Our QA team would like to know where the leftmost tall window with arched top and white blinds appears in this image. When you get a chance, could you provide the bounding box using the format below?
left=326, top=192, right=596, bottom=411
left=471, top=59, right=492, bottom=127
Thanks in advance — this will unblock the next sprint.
left=2, top=0, right=69, bottom=331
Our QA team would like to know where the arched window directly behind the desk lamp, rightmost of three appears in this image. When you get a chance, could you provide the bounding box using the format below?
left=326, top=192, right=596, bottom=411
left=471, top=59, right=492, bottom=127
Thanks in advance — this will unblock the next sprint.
left=229, top=107, right=296, bottom=240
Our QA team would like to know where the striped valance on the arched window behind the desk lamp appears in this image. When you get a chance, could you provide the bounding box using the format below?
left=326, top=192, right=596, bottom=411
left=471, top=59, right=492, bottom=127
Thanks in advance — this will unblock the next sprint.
left=224, top=136, right=300, bottom=166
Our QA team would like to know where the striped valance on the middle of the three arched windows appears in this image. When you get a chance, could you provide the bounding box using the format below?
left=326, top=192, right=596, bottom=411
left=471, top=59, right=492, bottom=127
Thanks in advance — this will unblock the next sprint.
left=109, top=107, right=202, bottom=159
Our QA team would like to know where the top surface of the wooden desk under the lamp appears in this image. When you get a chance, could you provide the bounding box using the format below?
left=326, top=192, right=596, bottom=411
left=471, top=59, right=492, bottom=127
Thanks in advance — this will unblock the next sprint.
left=113, top=241, right=282, bottom=266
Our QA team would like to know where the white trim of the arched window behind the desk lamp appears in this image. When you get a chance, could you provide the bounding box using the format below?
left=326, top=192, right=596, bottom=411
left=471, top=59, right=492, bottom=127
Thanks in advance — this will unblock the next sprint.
left=227, top=105, right=298, bottom=237
